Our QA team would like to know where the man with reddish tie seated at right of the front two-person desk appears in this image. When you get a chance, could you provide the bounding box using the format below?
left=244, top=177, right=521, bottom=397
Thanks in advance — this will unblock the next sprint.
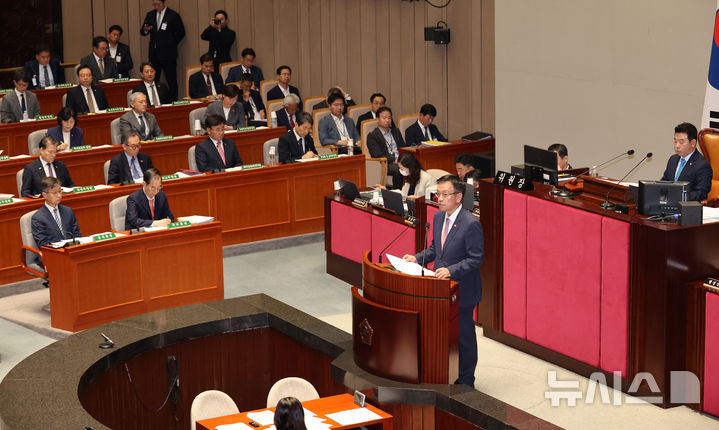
left=125, top=167, right=175, bottom=230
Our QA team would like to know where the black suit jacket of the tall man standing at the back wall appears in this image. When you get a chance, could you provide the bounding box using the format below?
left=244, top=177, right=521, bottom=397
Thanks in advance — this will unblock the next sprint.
left=140, top=7, right=185, bottom=62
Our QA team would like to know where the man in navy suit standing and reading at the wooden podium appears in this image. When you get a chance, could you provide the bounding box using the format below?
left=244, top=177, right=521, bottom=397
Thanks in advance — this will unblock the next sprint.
left=403, top=175, right=484, bottom=387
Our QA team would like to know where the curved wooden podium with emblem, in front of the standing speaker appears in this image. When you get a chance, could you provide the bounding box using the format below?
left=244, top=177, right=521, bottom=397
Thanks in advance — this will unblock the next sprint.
left=352, top=251, right=459, bottom=384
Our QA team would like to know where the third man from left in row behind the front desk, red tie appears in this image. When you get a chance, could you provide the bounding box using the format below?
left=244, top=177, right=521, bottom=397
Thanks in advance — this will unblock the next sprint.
left=195, top=115, right=242, bottom=172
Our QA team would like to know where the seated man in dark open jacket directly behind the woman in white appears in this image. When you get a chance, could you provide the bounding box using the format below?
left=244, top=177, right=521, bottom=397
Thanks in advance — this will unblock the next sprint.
left=367, top=107, right=405, bottom=188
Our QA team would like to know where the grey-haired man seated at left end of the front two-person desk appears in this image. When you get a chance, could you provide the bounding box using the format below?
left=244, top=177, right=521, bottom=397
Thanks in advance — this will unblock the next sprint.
left=30, top=178, right=82, bottom=252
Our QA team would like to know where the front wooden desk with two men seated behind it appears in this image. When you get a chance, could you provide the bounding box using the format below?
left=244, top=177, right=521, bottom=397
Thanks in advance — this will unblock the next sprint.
left=42, top=222, right=225, bottom=331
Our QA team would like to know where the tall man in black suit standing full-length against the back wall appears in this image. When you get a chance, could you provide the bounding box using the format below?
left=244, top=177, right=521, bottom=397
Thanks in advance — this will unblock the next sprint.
left=140, top=0, right=185, bottom=100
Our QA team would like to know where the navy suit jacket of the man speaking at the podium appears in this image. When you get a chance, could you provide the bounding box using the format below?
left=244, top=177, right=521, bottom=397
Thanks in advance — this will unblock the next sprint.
left=415, top=208, right=484, bottom=308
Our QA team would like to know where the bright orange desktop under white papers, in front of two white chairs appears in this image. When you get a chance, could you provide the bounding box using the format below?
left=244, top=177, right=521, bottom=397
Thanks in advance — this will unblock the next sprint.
left=197, top=394, right=393, bottom=430
